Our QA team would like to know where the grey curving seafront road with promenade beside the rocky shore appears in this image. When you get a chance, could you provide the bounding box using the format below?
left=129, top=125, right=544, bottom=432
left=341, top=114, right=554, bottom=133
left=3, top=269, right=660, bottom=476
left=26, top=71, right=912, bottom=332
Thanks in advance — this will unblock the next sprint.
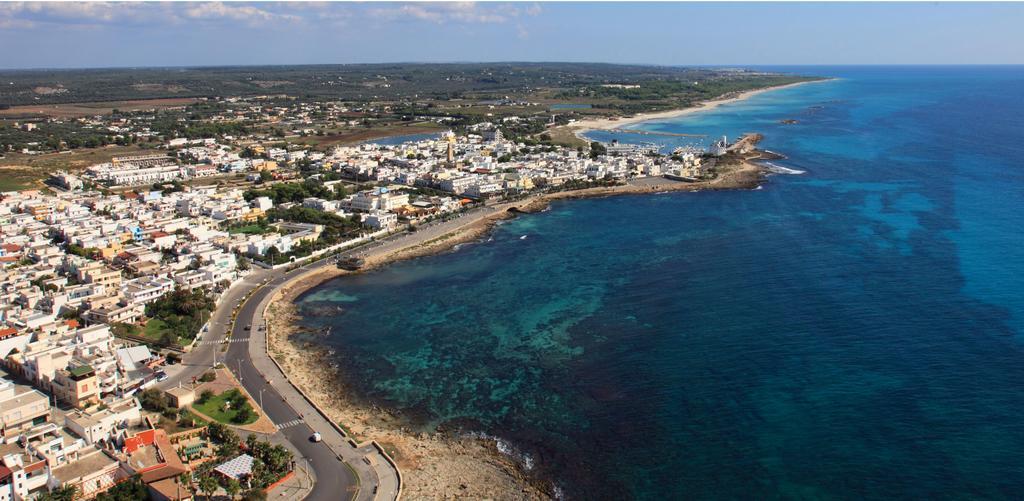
left=159, top=202, right=497, bottom=501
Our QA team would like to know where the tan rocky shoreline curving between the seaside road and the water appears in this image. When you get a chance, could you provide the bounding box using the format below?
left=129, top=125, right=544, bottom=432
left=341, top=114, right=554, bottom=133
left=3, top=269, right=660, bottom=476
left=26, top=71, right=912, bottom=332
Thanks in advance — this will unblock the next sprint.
left=266, top=156, right=767, bottom=499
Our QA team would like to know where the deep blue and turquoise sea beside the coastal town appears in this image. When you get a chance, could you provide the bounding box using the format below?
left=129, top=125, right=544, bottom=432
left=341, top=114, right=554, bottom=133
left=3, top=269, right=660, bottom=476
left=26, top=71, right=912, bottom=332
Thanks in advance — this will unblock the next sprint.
left=299, top=67, right=1024, bottom=500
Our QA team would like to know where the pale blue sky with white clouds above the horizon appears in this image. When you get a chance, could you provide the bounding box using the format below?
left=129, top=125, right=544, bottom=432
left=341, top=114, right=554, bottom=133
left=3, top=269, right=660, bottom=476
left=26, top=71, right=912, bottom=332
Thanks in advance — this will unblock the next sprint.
left=0, top=2, right=1024, bottom=69
